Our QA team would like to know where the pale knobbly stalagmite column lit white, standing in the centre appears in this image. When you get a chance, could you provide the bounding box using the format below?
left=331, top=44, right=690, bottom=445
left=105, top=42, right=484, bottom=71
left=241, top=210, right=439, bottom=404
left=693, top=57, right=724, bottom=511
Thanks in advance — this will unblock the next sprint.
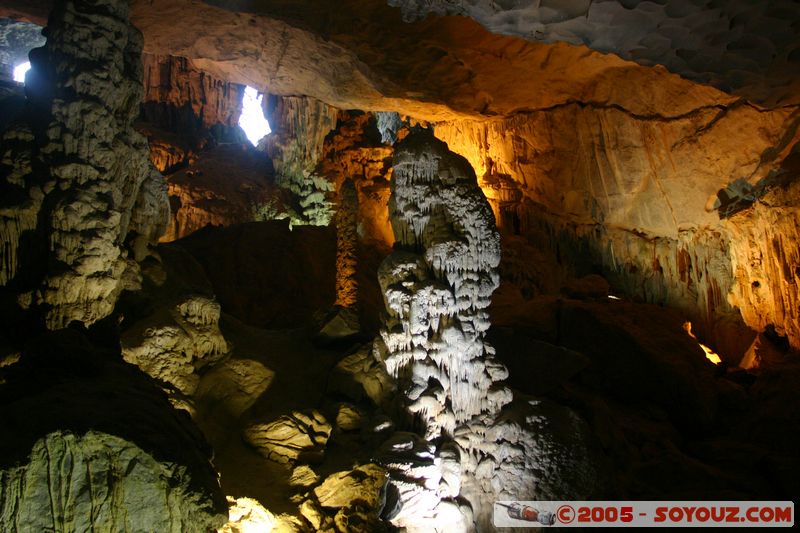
left=378, top=128, right=511, bottom=438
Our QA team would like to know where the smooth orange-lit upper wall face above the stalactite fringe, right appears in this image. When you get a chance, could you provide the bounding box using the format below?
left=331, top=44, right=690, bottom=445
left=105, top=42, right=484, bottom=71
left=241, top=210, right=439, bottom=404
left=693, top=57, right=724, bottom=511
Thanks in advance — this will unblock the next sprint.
left=436, top=102, right=800, bottom=238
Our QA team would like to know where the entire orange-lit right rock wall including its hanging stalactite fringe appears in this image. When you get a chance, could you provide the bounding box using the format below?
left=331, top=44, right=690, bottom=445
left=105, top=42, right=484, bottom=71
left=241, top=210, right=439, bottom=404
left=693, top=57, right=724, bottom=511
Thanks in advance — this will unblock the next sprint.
left=436, top=103, right=800, bottom=355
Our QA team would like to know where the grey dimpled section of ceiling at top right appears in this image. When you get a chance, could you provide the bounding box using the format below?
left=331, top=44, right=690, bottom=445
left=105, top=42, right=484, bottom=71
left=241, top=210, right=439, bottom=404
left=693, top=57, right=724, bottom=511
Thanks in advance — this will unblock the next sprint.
left=388, top=0, right=800, bottom=105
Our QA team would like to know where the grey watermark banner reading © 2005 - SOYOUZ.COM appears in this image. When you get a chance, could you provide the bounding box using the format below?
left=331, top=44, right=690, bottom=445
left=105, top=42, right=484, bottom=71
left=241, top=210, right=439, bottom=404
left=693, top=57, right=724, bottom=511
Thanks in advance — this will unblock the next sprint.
left=494, top=501, right=794, bottom=528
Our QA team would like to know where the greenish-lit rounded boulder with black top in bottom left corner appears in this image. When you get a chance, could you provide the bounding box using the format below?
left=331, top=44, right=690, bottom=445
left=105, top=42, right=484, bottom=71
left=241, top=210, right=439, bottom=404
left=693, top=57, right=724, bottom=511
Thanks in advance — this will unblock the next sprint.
left=0, top=330, right=227, bottom=533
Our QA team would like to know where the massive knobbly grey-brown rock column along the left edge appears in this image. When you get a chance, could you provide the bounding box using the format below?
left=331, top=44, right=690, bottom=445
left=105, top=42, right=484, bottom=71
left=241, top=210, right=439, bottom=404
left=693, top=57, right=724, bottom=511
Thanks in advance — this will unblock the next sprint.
left=0, top=1, right=169, bottom=328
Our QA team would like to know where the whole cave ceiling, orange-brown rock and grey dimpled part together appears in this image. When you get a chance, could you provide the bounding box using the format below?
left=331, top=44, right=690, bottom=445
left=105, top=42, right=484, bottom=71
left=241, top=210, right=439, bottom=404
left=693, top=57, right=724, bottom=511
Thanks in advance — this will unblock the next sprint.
left=0, top=0, right=800, bottom=121
